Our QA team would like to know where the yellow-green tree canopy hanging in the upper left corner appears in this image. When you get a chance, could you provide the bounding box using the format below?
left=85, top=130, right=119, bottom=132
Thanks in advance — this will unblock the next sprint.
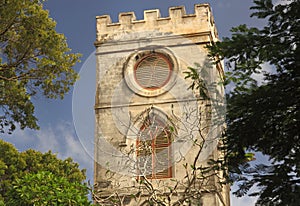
left=0, top=0, right=79, bottom=133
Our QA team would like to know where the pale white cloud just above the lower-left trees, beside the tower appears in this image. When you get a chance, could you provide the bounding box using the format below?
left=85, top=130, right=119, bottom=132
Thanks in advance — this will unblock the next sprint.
left=3, top=122, right=93, bottom=180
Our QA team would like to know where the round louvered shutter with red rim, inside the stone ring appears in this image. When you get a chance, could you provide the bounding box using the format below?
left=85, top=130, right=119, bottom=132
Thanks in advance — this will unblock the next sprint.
left=134, top=54, right=172, bottom=90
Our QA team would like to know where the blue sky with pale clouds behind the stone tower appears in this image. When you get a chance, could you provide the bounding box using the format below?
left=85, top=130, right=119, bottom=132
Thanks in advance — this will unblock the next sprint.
left=4, top=0, right=286, bottom=206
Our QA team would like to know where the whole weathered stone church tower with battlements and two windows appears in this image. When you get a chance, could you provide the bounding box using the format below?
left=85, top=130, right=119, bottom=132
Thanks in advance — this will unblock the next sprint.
left=94, top=4, right=229, bottom=206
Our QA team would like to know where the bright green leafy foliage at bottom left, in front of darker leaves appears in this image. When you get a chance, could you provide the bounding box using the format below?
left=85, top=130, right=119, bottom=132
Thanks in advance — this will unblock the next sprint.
left=6, top=171, right=91, bottom=206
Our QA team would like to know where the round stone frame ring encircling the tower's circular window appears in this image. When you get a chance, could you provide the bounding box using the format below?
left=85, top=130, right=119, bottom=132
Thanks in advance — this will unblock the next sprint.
left=124, top=49, right=178, bottom=97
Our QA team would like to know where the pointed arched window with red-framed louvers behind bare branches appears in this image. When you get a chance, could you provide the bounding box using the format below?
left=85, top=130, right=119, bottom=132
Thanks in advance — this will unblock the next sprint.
left=136, top=115, right=172, bottom=179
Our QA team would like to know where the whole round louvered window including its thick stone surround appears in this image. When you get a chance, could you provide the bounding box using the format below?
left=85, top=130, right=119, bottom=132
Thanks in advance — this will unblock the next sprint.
left=124, top=48, right=178, bottom=97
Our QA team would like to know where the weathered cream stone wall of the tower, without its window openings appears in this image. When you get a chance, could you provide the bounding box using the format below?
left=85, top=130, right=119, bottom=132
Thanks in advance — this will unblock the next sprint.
left=94, top=4, right=229, bottom=205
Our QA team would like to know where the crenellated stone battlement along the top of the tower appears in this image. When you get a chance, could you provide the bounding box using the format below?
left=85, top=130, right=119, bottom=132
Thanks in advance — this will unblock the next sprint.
left=96, top=4, right=218, bottom=44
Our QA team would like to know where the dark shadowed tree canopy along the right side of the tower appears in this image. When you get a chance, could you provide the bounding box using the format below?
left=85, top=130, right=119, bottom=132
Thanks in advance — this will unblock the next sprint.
left=210, top=0, right=300, bottom=206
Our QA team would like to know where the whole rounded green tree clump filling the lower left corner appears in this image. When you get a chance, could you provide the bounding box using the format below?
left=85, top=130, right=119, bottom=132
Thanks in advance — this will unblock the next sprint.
left=0, top=140, right=90, bottom=205
